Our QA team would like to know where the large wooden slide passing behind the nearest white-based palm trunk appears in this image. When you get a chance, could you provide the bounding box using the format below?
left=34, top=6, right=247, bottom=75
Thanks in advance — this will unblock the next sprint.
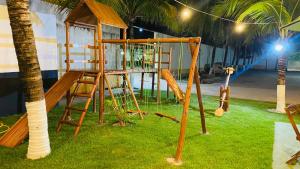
left=0, top=71, right=83, bottom=147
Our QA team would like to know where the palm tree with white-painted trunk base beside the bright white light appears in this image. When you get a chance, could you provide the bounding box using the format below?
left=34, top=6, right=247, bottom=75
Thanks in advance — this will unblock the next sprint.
left=212, top=0, right=300, bottom=112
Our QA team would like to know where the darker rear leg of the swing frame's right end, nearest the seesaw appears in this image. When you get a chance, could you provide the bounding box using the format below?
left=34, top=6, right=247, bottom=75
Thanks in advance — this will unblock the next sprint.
left=190, top=44, right=207, bottom=134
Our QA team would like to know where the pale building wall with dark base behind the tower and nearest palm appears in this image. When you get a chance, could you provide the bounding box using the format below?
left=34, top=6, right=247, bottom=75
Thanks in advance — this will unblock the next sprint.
left=0, top=0, right=121, bottom=116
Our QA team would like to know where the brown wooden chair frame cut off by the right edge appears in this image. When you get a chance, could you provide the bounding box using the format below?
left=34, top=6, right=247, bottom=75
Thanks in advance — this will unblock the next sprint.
left=285, top=104, right=300, bottom=165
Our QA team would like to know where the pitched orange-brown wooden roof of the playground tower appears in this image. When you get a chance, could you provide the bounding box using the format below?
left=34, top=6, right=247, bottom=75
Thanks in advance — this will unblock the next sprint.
left=66, top=0, right=127, bottom=29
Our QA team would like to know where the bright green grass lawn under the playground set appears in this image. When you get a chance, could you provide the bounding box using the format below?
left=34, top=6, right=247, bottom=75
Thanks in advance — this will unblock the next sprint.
left=0, top=95, right=288, bottom=169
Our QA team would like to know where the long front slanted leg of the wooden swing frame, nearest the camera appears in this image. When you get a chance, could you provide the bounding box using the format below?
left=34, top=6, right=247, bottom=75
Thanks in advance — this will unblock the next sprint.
left=175, top=42, right=200, bottom=163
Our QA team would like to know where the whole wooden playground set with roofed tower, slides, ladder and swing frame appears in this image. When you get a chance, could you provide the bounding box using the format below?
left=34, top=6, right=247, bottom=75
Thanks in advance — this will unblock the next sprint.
left=0, top=0, right=206, bottom=164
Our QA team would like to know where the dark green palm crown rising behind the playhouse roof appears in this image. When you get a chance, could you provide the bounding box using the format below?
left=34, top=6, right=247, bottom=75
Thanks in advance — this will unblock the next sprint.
left=44, top=0, right=178, bottom=38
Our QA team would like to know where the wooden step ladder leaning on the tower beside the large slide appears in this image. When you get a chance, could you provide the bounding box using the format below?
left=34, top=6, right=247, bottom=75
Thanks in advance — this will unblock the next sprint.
left=56, top=72, right=101, bottom=136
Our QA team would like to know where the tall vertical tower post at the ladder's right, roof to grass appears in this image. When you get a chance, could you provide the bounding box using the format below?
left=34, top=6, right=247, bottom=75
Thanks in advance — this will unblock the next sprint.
left=97, top=20, right=104, bottom=124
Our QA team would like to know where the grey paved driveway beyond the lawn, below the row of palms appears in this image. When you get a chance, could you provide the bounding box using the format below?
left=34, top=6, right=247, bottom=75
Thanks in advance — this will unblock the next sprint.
left=131, top=71, right=300, bottom=104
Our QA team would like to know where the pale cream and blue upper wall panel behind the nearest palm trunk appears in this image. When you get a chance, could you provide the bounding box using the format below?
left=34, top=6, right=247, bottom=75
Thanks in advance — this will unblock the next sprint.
left=0, top=5, right=58, bottom=73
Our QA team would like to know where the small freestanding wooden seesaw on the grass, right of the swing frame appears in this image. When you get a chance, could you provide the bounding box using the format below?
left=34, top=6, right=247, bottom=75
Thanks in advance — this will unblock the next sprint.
left=215, top=67, right=234, bottom=117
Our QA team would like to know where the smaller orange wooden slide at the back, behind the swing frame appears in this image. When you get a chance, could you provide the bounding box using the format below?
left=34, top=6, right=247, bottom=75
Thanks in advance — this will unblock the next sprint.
left=161, top=69, right=184, bottom=102
